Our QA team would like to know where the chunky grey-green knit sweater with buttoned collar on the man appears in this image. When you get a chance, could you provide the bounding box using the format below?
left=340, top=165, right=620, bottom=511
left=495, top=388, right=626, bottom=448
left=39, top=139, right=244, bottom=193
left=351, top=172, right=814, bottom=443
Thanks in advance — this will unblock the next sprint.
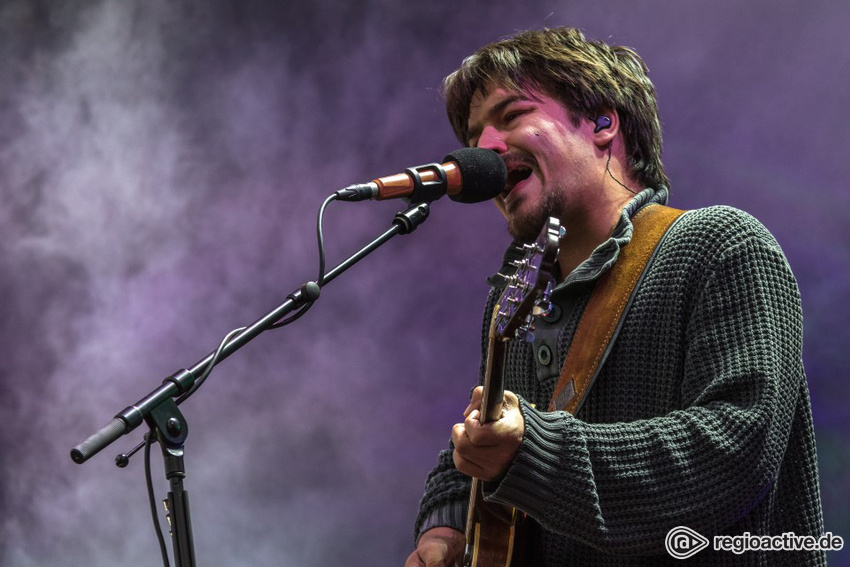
left=416, top=190, right=825, bottom=567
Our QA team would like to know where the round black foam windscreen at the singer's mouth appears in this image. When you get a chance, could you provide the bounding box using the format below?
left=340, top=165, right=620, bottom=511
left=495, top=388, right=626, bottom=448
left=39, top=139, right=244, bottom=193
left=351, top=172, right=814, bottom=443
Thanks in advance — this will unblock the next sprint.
left=443, top=148, right=508, bottom=203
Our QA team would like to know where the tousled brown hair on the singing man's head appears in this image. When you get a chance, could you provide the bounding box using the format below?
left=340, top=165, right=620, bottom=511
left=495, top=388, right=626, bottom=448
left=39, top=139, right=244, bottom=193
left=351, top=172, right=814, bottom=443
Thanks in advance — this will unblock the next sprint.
left=443, top=28, right=669, bottom=187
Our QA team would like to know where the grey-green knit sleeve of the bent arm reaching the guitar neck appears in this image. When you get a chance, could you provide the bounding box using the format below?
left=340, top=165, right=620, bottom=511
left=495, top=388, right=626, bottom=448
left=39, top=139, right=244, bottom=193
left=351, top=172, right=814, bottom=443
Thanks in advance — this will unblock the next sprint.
left=485, top=214, right=805, bottom=555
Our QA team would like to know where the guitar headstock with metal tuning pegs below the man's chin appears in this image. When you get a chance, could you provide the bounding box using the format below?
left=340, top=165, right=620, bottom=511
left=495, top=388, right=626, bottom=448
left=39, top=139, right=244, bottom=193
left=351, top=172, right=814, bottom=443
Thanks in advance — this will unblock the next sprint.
left=491, top=217, right=562, bottom=341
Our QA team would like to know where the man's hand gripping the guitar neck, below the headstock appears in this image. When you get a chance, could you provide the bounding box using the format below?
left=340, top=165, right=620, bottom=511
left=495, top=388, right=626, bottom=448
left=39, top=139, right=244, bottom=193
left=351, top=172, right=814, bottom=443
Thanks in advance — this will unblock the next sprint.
left=452, top=386, right=525, bottom=481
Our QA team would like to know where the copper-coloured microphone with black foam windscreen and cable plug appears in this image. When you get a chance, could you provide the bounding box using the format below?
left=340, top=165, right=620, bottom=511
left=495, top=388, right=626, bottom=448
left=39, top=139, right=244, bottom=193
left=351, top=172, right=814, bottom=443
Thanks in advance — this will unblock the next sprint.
left=335, top=148, right=508, bottom=203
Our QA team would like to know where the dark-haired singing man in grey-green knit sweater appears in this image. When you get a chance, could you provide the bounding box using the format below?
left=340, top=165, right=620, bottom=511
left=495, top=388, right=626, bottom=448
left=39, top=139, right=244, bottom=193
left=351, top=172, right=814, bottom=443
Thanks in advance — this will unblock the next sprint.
left=406, top=28, right=825, bottom=567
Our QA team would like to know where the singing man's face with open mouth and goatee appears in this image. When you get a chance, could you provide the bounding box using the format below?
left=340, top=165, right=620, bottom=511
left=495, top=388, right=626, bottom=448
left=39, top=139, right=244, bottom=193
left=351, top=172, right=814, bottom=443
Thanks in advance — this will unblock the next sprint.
left=468, top=83, right=599, bottom=242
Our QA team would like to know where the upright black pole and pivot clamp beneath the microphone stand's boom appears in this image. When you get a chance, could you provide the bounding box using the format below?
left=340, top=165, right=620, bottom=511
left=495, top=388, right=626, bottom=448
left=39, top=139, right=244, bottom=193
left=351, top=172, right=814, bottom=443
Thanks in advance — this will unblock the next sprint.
left=145, top=398, right=195, bottom=567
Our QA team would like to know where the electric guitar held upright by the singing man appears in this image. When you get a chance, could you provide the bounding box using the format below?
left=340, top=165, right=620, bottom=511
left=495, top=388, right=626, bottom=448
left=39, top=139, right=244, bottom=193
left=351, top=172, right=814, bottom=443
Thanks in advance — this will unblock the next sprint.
left=463, top=217, right=561, bottom=567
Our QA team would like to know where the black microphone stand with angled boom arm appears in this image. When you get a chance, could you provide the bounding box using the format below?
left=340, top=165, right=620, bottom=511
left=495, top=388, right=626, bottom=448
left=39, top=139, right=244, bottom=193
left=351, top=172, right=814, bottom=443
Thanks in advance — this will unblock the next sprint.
left=71, top=203, right=430, bottom=567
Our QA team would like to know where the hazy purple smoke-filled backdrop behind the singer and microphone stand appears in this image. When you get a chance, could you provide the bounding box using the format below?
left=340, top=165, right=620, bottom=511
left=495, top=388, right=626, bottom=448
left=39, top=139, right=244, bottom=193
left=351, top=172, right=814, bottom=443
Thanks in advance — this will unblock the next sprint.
left=0, top=0, right=850, bottom=567
